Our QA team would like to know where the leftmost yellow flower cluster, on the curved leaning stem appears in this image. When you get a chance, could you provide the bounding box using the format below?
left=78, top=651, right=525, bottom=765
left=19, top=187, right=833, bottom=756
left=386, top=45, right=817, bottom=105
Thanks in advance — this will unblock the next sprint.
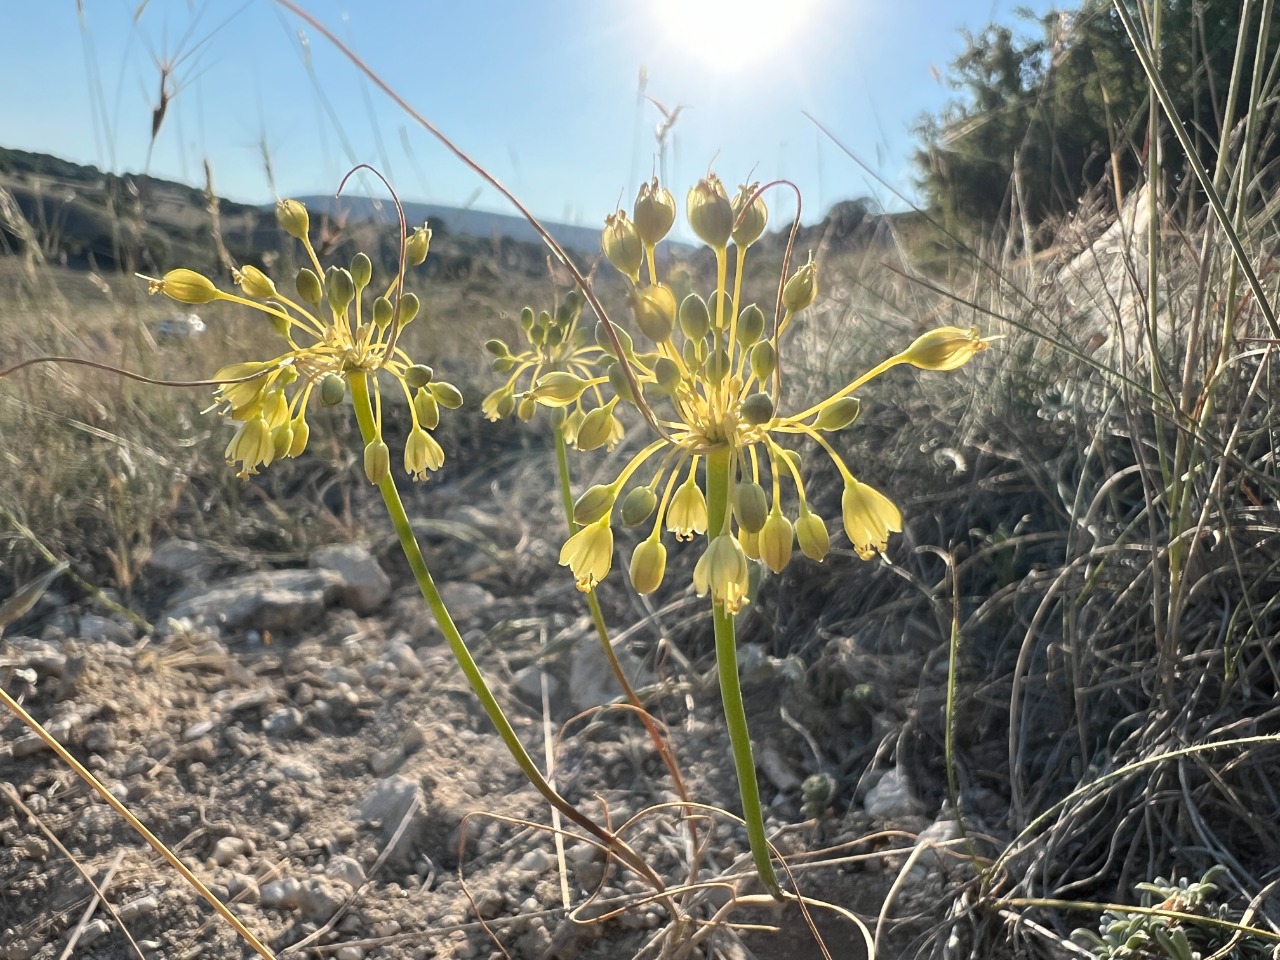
left=143, top=200, right=462, bottom=483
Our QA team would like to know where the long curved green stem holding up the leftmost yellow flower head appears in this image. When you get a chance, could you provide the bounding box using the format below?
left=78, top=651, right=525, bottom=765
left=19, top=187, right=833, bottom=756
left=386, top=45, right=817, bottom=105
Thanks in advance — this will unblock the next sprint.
left=348, top=375, right=663, bottom=891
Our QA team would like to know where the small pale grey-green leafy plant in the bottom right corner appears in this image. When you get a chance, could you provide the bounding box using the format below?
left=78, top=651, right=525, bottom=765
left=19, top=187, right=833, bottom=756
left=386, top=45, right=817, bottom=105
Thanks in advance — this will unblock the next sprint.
left=1071, top=864, right=1274, bottom=960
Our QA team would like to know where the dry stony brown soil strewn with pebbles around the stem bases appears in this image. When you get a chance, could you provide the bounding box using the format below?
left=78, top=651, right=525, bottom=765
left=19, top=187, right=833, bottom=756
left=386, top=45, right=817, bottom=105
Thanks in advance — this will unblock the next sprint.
left=0, top=463, right=954, bottom=960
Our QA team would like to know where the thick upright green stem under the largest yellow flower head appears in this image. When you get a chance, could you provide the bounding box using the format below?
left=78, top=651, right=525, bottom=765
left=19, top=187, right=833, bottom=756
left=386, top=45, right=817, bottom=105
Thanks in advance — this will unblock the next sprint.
left=707, top=447, right=783, bottom=900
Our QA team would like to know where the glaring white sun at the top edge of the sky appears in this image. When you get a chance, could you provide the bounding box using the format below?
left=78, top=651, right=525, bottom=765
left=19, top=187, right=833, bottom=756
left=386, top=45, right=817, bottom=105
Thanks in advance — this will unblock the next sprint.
left=653, top=0, right=814, bottom=73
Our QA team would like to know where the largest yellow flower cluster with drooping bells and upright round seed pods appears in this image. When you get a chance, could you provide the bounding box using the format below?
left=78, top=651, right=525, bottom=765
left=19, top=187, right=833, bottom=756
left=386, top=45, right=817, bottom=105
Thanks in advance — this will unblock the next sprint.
left=529, top=175, right=988, bottom=612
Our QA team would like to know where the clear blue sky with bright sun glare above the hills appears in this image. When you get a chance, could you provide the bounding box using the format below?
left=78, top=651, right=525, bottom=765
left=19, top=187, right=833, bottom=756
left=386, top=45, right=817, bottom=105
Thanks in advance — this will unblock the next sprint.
left=0, top=0, right=1052, bottom=224
